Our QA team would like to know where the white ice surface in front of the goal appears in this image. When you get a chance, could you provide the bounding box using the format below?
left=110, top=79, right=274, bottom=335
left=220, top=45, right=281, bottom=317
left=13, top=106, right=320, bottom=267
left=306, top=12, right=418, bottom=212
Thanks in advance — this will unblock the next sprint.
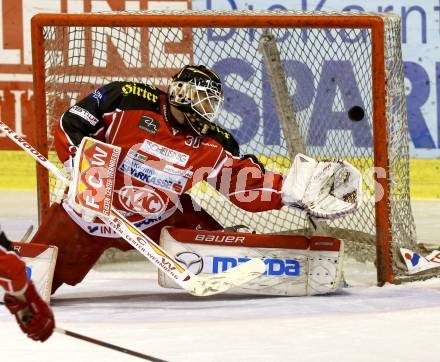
left=0, top=194, right=440, bottom=362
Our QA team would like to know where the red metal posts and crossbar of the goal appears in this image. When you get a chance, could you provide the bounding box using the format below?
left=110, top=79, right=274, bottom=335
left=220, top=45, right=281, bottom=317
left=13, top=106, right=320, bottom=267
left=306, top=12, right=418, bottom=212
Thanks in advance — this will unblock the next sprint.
left=31, top=13, right=388, bottom=285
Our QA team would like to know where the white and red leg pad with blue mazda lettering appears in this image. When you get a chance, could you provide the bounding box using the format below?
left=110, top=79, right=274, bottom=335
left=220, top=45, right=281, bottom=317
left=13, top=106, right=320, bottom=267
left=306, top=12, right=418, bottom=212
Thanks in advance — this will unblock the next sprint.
left=158, top=227, right=344, bottom=296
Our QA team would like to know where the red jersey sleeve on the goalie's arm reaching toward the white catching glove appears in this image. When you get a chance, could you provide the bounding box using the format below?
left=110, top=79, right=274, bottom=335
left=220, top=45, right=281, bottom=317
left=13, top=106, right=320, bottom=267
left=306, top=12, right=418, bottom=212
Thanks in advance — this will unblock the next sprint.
left=207, top=151, right=283, bottom=212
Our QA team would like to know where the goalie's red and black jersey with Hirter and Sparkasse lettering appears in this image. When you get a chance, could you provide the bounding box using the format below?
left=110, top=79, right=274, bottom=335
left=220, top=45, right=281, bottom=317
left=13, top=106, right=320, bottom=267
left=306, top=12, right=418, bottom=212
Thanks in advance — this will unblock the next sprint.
left=55, top=82, right=282, bottom=235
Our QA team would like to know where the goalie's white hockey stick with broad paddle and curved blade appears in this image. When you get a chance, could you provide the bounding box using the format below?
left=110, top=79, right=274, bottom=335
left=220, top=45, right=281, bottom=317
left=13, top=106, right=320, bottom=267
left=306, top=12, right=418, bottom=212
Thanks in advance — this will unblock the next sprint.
left=0, top=121, right=266, bottom=297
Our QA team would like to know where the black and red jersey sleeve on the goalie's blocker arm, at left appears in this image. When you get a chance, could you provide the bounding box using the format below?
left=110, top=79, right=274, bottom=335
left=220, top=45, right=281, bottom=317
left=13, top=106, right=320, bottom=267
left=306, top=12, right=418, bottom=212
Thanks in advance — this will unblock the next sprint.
left=55, top=82, right=124, bottom=162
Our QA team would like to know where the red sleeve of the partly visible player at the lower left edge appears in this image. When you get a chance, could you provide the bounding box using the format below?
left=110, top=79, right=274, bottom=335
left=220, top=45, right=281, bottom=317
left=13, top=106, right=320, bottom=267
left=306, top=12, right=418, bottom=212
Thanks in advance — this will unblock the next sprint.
left=0, top=245, right=27, bottom=294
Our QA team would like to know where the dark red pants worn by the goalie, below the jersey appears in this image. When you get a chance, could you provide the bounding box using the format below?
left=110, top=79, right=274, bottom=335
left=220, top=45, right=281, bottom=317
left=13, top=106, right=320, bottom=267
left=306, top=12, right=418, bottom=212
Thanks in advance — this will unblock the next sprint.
left=31, top=195, right=221, bottom=294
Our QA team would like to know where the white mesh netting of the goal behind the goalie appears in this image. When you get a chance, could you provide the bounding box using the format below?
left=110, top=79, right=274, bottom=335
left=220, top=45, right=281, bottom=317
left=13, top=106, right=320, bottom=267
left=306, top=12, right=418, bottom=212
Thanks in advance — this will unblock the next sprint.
left=37, top=13, right=416, bottom=273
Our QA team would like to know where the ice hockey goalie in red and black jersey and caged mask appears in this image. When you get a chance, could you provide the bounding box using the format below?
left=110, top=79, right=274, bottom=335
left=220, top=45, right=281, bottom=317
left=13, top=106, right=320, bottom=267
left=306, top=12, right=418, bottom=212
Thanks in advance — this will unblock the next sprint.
left=32, top=65, right=361, bottom=293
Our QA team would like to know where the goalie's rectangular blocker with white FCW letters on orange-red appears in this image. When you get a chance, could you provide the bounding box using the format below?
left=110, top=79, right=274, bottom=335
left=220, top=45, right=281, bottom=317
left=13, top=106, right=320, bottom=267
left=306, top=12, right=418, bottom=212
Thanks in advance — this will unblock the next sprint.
left=73, top=137, right=121, bottom=216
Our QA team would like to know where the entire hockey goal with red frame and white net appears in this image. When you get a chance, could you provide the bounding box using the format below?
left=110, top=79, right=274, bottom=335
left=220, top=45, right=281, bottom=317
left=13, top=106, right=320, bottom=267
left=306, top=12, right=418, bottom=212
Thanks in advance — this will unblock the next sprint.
left=32, top=11, right=417, bottom=285
